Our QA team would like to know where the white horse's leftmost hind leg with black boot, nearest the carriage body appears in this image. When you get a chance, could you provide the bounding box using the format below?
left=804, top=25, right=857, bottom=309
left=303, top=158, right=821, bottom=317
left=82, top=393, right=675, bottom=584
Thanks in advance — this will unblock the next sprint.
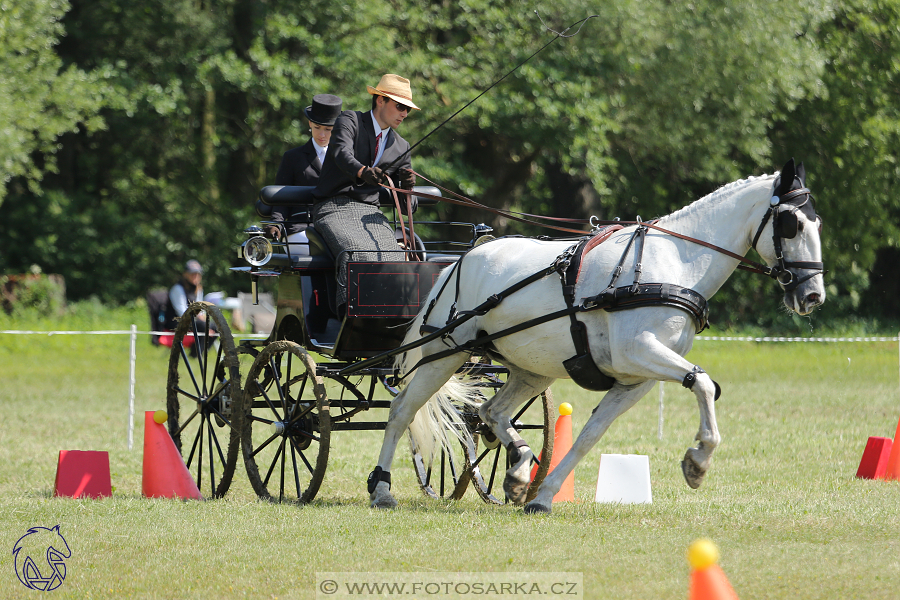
left=369, top=354, right=466, bottom=508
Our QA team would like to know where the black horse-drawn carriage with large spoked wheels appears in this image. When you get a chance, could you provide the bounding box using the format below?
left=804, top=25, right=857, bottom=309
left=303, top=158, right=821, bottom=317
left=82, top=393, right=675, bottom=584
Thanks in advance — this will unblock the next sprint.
left=167, top=186, right=553, bottom=503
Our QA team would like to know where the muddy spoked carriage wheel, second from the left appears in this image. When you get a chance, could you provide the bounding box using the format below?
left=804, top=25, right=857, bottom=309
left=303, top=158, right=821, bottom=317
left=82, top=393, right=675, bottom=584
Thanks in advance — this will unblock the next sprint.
left=241, top=341, right=331, bottom=503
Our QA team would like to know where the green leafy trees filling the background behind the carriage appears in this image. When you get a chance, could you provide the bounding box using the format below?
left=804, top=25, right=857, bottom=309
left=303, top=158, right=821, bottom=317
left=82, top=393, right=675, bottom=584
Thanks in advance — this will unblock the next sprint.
left=0, top=0, right=900, bottom=330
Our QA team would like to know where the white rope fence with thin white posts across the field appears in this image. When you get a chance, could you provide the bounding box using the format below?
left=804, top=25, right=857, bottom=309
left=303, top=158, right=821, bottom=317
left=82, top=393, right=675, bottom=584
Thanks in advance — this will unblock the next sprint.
left=0, top=325, right=900, bottom=450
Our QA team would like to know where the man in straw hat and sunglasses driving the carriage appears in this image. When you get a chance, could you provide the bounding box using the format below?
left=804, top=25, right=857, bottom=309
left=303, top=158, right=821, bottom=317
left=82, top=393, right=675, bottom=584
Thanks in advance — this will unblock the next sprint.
left=313, top=74, right=419, bottom=317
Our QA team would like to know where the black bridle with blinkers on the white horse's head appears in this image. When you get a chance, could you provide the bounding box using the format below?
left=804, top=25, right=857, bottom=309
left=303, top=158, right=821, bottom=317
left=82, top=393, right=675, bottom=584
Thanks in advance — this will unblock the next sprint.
left=751, top=187, right=825, bottom=292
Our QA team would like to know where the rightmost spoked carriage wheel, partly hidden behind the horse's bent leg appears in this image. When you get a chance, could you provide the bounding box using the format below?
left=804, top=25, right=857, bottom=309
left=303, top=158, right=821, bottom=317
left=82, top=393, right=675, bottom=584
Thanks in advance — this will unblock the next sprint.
left=466, top=388, right=554, bottom=504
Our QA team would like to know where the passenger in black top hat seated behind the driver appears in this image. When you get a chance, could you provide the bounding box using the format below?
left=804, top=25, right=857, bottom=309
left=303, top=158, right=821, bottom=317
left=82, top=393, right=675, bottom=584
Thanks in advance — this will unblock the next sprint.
left=267, top=94, right=343, bottom=254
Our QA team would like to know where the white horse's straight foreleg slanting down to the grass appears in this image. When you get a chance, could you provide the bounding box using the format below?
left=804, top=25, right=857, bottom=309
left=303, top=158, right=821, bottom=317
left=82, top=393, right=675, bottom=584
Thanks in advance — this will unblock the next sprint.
left=525, top=381, right=656, bottom=513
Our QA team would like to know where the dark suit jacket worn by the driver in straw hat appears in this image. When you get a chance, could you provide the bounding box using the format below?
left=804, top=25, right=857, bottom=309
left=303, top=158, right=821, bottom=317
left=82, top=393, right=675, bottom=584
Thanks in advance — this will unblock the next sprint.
left=313, top=110, right=412, bottom=206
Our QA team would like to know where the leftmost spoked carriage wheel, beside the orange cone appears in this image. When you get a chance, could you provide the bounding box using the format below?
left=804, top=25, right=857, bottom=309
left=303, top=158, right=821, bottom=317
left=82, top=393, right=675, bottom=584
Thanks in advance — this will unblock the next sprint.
left=166, top=302, right=241, bottom=498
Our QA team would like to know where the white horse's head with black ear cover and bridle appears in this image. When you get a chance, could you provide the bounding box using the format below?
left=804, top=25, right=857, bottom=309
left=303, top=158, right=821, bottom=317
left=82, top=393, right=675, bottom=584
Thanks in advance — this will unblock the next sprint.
left=753, top=159, right=825, bottom=315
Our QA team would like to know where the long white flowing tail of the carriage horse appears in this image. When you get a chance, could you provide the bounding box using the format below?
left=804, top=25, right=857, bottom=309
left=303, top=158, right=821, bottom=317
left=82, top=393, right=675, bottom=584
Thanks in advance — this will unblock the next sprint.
left=394, top=268, right=484, bottom=464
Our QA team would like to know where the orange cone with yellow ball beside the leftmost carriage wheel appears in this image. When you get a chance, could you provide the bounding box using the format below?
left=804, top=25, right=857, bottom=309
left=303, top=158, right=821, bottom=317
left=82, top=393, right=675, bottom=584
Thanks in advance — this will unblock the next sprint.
left=141, top=410, right=203, bottom=500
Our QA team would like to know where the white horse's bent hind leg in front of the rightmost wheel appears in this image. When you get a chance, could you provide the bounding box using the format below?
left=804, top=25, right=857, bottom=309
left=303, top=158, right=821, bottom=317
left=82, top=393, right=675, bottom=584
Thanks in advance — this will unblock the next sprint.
left=478, top=367, right=553, bottom=504
